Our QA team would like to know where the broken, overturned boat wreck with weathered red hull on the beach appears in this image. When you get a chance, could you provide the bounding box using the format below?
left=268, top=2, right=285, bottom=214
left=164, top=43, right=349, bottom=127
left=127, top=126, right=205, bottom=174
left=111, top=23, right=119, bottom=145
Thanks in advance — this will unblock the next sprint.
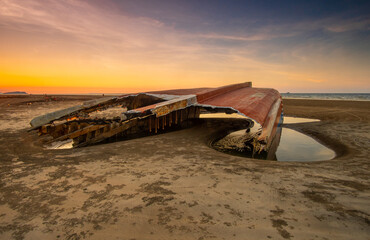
left=30, top=82, right=282, bottom=157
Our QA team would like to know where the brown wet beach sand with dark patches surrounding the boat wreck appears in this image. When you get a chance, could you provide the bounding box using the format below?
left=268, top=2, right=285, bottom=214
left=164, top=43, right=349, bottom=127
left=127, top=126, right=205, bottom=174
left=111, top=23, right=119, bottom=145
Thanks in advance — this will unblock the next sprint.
left=0, top=96, right=370, bottom=239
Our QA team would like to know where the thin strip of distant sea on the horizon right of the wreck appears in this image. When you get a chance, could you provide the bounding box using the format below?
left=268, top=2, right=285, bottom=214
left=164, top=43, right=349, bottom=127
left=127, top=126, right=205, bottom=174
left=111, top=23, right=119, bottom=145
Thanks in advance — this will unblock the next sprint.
left=281, top=93, right=370, bottom=101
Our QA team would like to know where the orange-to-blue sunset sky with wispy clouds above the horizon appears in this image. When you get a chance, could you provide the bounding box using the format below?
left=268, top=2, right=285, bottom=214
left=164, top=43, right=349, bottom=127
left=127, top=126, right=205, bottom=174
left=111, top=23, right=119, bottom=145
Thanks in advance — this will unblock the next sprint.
left=0, top=0, right=370, bottom=94
